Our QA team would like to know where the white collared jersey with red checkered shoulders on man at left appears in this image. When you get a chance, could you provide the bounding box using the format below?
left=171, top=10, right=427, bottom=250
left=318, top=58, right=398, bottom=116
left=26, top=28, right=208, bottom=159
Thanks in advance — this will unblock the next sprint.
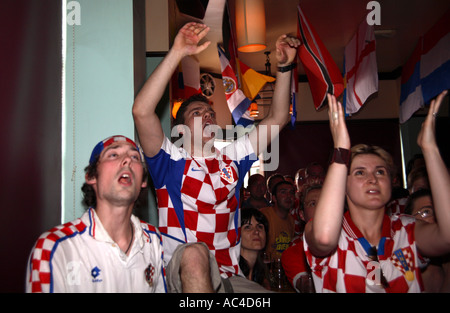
left=26, top=209, right=166, bottom=293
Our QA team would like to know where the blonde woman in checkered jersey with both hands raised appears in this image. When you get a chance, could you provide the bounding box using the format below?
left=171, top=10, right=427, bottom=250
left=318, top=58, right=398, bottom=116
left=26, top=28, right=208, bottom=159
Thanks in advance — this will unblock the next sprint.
left=305, top=92, right=450, bottom=293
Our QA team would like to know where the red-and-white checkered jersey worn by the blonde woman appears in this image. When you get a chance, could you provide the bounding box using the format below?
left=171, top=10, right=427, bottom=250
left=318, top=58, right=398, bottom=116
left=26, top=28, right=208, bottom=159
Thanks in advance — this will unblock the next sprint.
left=304, top=212, right=422, bottom=293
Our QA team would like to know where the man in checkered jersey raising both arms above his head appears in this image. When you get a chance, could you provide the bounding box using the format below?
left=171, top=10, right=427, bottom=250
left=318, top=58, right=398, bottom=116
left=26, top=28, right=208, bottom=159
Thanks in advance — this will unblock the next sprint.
left=133, top=23, right=299, bottom=292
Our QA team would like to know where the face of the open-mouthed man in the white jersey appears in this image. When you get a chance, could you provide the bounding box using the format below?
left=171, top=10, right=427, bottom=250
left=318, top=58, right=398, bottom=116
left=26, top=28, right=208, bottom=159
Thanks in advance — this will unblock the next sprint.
left=86, top=141, right=147, bottom=205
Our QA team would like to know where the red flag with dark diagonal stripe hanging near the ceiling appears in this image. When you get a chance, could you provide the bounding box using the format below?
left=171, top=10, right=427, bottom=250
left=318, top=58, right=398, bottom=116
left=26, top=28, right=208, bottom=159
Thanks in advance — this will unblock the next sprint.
left=297, top=5, right=344, bottom=110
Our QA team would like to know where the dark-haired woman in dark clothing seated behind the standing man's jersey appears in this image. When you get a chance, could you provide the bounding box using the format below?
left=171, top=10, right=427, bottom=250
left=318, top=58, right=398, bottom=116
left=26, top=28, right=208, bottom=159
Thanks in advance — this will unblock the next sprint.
left=239, top=208, right=270, bottom=289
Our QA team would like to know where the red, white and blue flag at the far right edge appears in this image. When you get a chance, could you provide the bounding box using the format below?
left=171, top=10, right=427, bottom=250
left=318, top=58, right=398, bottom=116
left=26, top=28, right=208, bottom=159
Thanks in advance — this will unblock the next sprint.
left=399, top=10, right=450, bottom=123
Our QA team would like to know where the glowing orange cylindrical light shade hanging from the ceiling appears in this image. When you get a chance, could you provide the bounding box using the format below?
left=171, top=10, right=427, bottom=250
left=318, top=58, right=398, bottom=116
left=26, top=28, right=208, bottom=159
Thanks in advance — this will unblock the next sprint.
left=236, top=0, right=266, bottom=52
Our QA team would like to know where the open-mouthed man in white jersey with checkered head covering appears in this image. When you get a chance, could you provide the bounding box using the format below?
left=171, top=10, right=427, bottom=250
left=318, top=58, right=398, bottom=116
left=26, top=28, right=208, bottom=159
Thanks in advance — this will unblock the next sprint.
left=26, top=136, right=166, bottom=293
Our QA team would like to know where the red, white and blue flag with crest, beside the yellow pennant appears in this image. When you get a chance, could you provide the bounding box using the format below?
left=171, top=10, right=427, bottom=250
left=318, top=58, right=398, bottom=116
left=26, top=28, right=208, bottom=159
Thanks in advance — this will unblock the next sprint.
left=217, top=45, right=254, bottom=126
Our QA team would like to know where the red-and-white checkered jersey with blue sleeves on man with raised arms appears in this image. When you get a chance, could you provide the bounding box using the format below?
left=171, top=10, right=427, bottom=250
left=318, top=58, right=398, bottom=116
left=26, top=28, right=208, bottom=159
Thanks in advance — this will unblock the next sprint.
left=146, top=136, right=256, bottom=277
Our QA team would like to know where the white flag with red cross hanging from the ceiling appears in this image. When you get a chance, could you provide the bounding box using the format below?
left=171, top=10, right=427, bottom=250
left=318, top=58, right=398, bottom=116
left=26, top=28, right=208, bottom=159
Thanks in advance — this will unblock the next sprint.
left=343, top=19, right=378, bottom=115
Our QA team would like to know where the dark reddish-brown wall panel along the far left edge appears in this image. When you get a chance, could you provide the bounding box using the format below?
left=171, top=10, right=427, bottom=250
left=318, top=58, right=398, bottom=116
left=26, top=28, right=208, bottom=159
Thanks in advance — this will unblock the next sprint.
left=0, top=0, right=62, bottom=292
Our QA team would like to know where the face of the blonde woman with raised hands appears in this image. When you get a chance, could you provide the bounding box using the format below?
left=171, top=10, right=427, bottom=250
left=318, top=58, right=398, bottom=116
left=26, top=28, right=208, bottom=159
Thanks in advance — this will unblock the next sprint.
left=347, top=154, right=391, bottom=210
